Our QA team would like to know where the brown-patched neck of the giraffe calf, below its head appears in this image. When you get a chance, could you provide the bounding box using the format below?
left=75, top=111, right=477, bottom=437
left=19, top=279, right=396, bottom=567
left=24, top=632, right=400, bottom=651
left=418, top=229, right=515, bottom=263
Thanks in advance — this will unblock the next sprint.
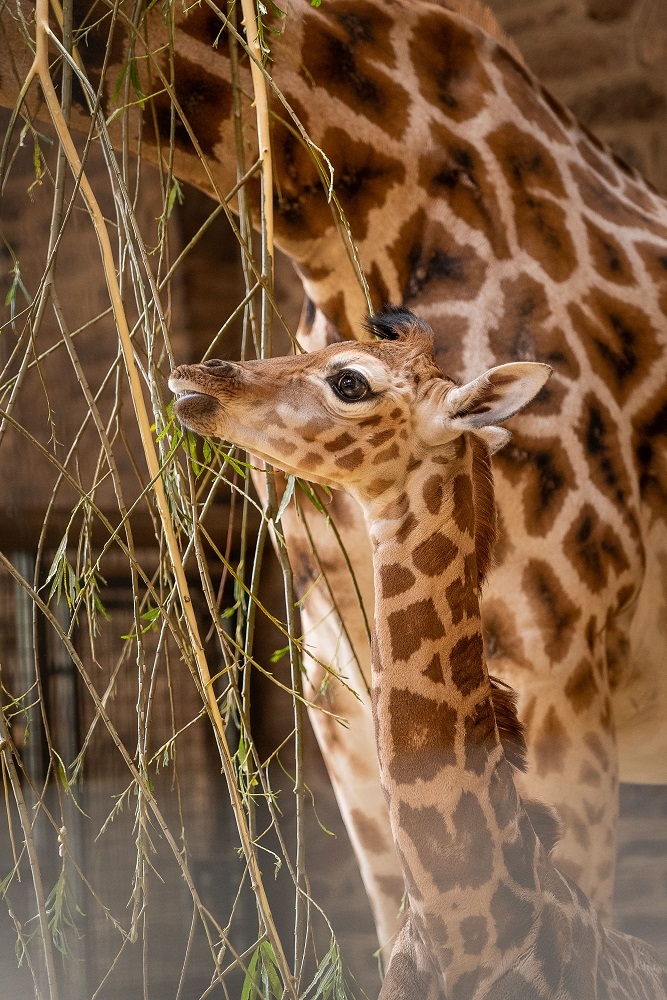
left=365, top=438, right=539, bottom=997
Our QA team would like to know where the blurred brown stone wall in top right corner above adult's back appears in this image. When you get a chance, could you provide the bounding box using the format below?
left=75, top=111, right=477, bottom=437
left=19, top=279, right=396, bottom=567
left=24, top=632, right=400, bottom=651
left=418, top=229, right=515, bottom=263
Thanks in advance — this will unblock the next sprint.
left=486, top=0, right=667, bottom=191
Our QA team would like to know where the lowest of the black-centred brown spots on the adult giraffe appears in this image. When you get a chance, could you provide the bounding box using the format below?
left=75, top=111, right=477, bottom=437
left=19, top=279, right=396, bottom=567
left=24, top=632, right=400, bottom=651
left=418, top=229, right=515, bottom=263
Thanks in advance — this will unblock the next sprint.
left=563, top=503, right=630, bottom=594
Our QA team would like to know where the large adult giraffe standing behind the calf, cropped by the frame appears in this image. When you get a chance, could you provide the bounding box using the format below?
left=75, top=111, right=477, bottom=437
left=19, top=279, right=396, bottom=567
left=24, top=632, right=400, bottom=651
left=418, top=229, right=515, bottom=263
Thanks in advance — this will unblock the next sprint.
left=0, top=0, right=667, bottom=956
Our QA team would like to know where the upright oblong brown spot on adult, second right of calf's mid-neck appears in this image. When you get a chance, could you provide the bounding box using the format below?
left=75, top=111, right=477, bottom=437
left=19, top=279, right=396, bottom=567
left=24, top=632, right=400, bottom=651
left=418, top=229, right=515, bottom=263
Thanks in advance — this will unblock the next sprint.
left=523, top=559, right=581, bottom=663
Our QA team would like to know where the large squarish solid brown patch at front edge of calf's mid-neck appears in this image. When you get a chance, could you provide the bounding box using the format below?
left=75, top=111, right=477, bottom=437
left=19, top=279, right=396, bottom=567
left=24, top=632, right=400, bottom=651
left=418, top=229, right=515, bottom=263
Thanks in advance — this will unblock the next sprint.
left=387, top=688, right=457, bottom=785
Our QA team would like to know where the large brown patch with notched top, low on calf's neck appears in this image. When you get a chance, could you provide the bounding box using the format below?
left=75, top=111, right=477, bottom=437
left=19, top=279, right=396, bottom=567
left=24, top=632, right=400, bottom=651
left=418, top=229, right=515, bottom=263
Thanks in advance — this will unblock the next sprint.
left=398, top=792, right=493, bottom=892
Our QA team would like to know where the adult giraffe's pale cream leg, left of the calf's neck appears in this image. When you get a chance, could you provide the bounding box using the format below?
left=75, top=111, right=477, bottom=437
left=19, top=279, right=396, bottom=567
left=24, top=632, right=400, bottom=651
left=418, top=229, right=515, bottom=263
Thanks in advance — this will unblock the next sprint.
left=281, top=491, right=403, bottom=959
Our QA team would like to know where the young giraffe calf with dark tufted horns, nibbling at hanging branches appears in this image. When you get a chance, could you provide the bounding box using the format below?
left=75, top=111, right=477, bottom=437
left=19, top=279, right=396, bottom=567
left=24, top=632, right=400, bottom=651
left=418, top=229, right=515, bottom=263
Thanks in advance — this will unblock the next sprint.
left=169, top=309, right=667, bottom=1000
